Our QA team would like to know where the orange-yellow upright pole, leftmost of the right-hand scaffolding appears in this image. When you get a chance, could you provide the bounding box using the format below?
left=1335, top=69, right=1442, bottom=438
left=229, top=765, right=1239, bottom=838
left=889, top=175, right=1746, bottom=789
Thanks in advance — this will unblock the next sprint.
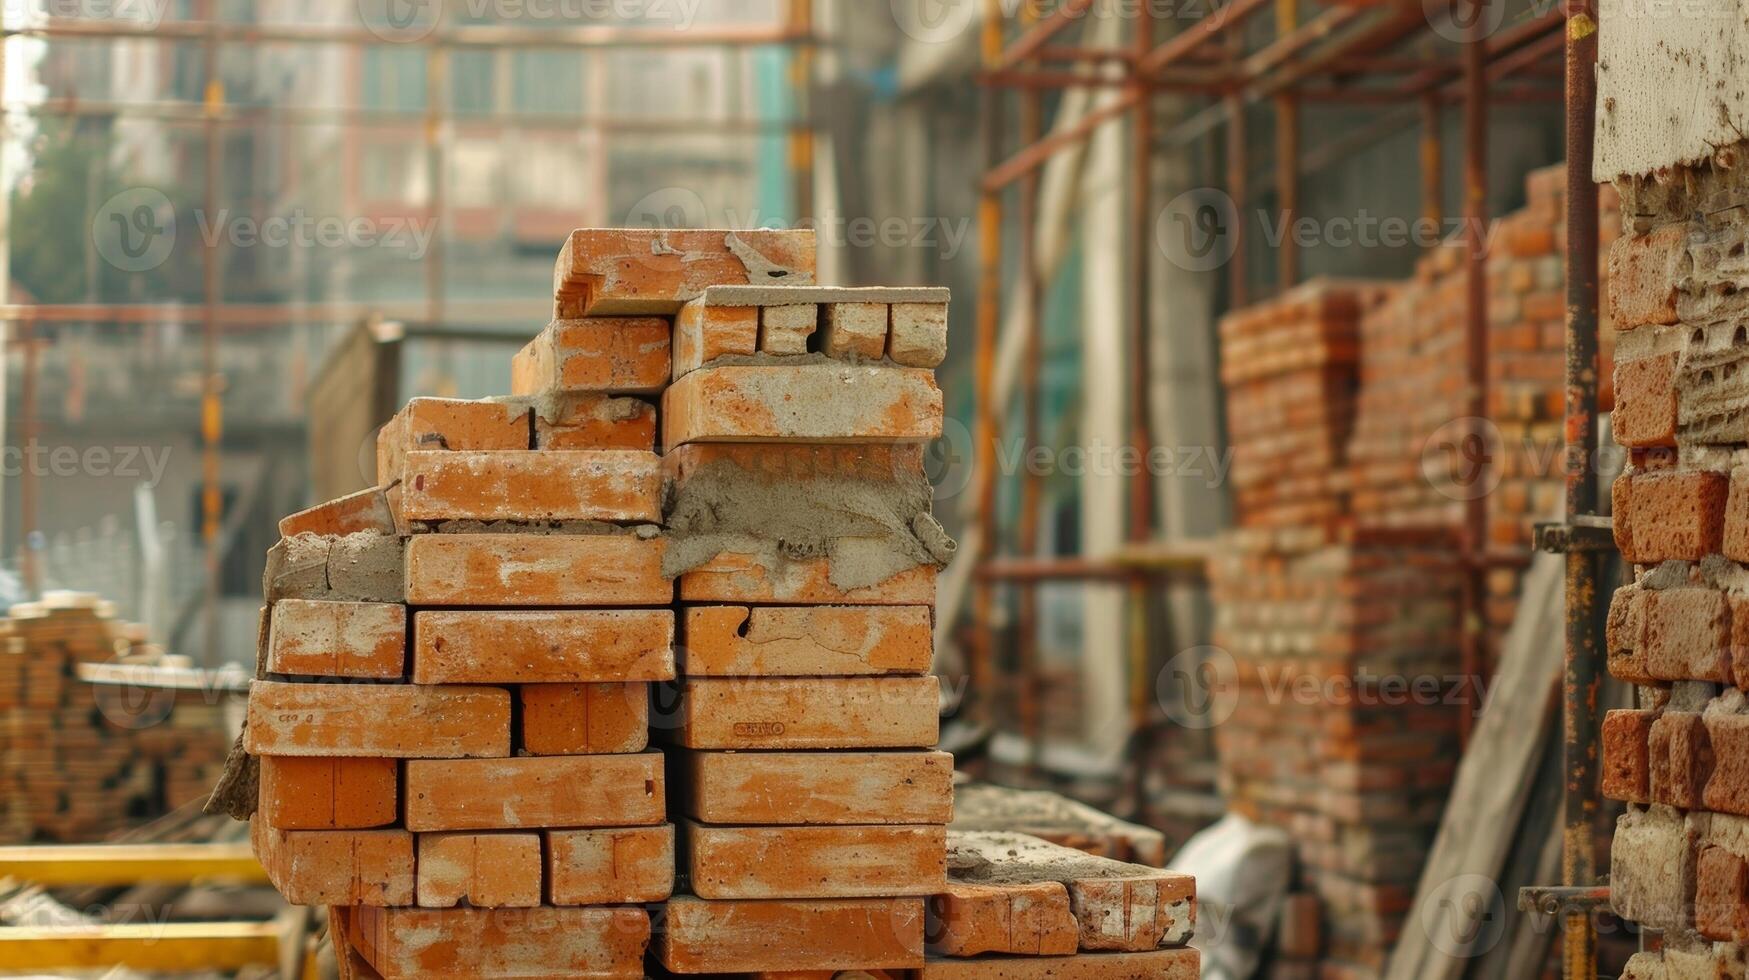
left=967, top=0, right=1002, bottom=735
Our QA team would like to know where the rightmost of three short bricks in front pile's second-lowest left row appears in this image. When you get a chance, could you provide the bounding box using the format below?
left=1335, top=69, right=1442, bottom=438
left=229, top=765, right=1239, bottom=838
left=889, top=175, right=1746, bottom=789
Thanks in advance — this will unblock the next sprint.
left=546, top=824, right=673, bottom=905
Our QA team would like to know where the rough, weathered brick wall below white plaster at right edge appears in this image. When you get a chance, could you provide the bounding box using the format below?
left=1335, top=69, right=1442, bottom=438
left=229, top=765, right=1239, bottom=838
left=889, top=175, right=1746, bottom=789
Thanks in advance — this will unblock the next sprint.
left=1602, top=156, right=1749, bottom=978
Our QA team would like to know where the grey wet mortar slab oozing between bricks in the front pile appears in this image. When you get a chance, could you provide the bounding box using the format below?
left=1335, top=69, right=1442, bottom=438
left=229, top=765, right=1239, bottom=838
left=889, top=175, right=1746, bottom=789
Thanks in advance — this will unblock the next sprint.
left=663, top=460, right=955, bottom=590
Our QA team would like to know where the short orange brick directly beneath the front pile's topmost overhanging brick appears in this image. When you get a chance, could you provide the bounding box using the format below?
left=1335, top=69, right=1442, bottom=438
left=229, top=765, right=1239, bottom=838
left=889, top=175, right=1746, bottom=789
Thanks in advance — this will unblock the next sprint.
left=511, top=317, right=670, bottom=396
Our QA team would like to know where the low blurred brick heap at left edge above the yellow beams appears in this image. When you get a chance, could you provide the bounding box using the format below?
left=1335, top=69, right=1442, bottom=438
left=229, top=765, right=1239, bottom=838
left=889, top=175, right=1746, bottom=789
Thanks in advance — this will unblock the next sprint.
left=0, top=592, right=229, bottom=842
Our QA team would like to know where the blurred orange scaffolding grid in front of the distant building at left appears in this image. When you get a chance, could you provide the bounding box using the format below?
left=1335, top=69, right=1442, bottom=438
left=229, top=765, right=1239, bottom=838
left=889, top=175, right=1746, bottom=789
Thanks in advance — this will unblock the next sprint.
left=0, top=0, right=819, bottom=665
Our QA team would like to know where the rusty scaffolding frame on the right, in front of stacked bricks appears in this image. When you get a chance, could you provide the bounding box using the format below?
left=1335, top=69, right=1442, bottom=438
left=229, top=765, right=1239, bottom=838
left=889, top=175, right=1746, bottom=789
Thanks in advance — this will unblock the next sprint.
left=971, top=0, right=1611, bottom=977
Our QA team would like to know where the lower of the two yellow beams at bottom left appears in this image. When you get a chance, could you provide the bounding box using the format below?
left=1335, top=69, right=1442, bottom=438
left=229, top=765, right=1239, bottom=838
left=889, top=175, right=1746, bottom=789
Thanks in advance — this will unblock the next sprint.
left=0, top=922, right=280, bottom=973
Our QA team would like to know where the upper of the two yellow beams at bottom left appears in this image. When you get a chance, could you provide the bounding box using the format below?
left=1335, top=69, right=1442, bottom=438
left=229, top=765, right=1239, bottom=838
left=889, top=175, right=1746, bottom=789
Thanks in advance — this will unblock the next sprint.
left=0, top=840, right=268, bottom=886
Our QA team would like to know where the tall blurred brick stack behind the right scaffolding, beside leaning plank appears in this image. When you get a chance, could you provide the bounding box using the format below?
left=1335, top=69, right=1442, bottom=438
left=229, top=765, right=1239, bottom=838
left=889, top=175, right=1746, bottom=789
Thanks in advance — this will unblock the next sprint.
left=1212, top=168, right=1614, bottom=977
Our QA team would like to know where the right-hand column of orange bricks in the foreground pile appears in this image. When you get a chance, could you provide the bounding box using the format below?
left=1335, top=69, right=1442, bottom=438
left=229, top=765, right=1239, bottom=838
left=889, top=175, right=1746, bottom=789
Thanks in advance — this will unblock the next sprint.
left=661, top=287, right=953, bottom=975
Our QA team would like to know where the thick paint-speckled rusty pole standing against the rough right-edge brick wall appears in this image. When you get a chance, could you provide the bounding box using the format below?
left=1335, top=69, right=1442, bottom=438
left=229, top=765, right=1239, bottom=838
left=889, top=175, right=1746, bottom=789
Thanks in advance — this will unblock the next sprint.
left=1560, top=0, right=1600, bottom=980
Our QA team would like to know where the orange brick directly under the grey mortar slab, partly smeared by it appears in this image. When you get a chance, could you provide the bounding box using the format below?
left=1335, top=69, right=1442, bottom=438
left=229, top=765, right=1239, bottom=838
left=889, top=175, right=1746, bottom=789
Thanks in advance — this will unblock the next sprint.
left=680, top=551, right=936, bottom=606
